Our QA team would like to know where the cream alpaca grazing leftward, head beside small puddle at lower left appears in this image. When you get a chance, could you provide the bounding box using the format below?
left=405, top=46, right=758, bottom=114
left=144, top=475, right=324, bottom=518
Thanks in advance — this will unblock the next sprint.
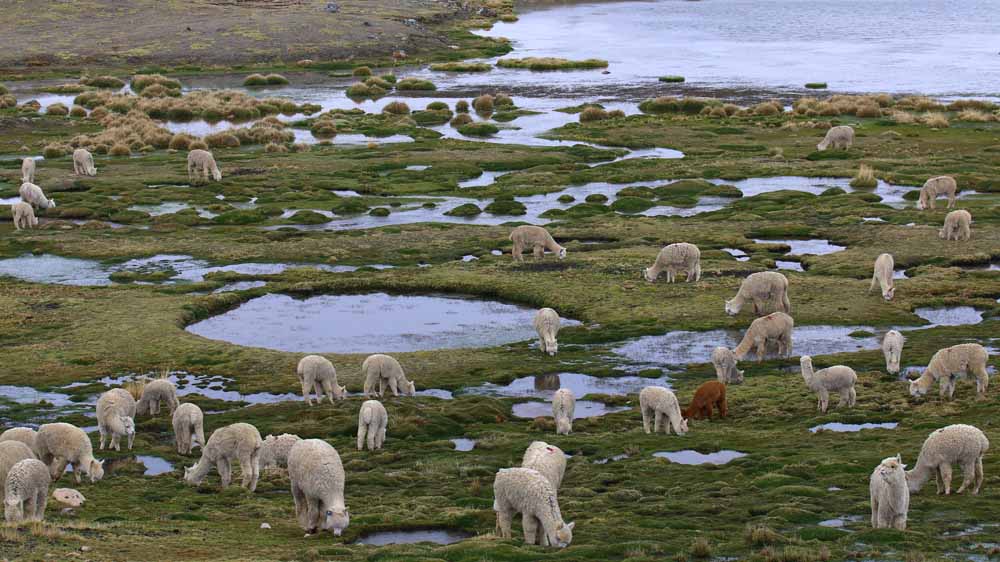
left=184, top=423, right=264, bottom=492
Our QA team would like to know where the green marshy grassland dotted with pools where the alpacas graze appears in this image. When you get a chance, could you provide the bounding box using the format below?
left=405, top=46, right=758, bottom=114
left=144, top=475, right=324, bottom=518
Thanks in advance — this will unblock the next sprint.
left=0, top=2, right=1000, bottom=562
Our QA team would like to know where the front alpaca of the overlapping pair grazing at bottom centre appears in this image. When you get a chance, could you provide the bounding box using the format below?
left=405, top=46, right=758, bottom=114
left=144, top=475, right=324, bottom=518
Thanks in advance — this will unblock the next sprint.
left=493, top=468, right=575, bottom=548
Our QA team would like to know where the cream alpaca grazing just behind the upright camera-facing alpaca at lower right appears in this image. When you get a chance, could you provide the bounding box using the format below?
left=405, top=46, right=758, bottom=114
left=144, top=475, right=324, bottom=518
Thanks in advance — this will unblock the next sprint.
left=906, top=424, right=990, bottom=496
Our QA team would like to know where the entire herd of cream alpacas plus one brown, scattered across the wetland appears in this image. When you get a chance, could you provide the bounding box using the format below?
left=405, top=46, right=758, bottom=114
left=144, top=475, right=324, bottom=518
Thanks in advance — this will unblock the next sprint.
left=0, top=126, right=989, bottom=547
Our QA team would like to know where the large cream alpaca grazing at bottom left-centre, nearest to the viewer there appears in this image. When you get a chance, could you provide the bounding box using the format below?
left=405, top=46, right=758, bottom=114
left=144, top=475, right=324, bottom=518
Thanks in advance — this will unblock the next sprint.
left=288, top=439, right=351, bottom=537
